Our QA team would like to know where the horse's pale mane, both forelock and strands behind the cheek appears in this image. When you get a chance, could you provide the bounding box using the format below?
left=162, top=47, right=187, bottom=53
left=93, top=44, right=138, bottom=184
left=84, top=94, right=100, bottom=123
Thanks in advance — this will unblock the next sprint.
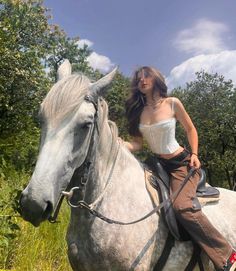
left=41, top=73, right=118, bottom=163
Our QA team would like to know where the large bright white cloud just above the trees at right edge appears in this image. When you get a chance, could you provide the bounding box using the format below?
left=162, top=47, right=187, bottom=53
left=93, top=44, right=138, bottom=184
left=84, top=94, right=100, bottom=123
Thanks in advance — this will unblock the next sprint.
left=166, top=50, right=236, bottom=90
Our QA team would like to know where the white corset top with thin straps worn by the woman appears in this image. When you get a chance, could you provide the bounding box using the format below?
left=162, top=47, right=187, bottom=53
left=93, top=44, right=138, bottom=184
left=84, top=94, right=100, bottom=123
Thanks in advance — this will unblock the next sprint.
left=139, top=118, right=180, bottom=154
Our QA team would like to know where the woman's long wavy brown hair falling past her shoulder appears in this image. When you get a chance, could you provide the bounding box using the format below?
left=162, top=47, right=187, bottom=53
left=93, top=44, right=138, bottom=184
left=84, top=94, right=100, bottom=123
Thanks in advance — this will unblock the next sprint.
left=125, top=66, right=167, bottom=136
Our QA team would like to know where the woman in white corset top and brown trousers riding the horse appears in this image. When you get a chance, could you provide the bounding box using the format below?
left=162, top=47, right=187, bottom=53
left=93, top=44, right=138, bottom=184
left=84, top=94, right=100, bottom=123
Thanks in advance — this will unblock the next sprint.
left=123, top=67, right=236, bottom=271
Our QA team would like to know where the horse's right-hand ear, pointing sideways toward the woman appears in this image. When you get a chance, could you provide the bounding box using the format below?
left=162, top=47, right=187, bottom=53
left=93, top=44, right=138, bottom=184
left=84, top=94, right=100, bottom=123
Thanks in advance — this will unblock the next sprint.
left=90, top=67, right=118, bottom=96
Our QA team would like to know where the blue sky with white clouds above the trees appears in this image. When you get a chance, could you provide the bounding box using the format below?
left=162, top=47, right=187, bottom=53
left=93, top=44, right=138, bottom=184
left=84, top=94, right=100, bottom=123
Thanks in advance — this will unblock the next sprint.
left=44, top=0, right=236, bottom=89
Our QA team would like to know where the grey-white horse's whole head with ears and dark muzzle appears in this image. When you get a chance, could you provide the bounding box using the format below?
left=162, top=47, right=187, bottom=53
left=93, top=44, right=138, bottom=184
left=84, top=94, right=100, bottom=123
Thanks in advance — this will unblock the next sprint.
left=20, top=61, right=116, bottom=226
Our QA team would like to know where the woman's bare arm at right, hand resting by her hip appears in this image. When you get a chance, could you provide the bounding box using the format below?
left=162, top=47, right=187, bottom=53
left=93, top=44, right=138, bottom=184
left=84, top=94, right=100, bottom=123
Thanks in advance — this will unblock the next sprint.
left=174, top=98, right=201, bottom=168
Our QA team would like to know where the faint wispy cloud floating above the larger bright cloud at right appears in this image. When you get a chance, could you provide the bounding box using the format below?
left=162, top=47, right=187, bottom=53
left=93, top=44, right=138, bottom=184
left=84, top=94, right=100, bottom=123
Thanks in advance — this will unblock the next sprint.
left=174, top=19, right=229, bottom=55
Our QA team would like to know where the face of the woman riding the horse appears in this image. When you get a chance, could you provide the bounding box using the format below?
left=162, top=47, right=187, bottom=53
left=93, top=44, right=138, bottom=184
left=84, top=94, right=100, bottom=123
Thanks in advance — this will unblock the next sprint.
left=137, top=70, right=154, bottom=94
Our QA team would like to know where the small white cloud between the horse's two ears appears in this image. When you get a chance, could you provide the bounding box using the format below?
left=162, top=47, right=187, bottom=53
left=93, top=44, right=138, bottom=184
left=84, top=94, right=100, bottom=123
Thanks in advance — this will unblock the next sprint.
left=87, top=52, right=114, bottom=73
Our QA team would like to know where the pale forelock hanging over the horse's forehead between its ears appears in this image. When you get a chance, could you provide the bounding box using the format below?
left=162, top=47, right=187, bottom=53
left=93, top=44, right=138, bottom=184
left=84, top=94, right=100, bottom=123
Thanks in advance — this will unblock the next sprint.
left=40, top=73, right=90, bottom=125
